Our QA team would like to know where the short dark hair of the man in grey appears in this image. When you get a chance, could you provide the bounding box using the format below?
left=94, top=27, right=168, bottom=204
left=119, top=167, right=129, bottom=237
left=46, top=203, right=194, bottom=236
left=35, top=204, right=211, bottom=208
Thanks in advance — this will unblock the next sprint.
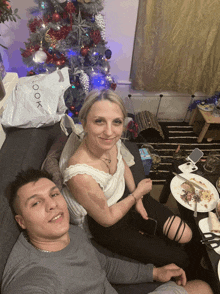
left=9, top=168, right=53, bottom=215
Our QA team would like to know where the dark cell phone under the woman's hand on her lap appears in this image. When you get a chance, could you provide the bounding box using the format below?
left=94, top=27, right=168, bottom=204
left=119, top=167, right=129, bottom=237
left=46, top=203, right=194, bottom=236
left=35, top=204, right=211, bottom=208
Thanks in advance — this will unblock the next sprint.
left=131, top=212, right=157, bottom=236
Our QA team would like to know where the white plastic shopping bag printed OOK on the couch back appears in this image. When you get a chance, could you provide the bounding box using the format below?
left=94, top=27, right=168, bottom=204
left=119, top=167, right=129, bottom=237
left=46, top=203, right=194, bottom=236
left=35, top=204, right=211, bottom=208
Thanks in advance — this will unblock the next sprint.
left=0, top=67, right=70, bottom=128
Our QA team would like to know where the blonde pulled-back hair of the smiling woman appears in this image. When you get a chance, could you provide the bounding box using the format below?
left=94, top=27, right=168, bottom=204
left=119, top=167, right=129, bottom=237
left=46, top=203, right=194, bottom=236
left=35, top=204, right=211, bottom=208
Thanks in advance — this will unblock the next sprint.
left=79, top=90, right=127, bottom=124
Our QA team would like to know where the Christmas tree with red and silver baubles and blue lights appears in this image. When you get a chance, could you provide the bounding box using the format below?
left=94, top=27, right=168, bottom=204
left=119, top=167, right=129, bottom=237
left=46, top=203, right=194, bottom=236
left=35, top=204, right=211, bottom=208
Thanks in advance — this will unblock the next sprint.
left=21, top=0, right=116, bottom=118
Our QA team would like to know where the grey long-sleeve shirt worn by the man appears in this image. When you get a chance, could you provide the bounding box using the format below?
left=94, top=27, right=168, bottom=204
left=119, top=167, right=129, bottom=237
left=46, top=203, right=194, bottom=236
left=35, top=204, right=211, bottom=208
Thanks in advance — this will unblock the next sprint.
left=2, top=226, right=186, bottom=294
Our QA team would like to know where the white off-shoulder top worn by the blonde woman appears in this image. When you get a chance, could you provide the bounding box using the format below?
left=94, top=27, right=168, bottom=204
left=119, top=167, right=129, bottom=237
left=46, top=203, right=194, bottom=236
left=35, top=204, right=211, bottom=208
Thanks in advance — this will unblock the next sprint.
left=62, top=140, right=125, bottom=229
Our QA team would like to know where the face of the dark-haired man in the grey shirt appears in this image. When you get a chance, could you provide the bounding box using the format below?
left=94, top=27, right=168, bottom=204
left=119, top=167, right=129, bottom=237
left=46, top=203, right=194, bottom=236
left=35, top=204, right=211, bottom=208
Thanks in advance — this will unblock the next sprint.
left=15, top=178, right=69, bottom=242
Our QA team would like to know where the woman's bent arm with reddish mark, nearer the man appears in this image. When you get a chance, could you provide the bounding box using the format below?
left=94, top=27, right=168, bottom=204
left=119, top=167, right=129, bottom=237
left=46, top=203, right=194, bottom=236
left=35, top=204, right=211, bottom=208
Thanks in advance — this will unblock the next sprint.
left=67, top=174, right=146, bottom=227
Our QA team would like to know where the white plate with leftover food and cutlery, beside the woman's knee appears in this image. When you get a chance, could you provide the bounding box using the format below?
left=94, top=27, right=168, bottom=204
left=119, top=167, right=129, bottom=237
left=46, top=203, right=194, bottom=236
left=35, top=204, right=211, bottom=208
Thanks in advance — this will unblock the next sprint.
left=170, top=173, right=219, bottom=212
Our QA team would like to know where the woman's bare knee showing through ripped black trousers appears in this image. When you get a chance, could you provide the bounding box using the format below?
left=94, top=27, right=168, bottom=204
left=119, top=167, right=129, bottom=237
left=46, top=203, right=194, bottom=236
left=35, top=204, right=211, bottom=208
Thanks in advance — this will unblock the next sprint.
left=163, top=215, right=192, bottom=243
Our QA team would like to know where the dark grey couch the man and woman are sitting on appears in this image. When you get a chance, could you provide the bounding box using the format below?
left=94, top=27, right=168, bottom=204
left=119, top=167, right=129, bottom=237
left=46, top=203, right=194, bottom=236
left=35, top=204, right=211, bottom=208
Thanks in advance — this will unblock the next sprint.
left=0, top=123, right=162, bottom=294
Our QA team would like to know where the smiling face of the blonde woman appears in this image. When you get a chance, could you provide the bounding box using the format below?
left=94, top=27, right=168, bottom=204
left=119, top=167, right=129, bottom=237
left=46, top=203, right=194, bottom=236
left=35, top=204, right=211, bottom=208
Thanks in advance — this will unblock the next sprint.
left=83, top=100, right=124, bottom=150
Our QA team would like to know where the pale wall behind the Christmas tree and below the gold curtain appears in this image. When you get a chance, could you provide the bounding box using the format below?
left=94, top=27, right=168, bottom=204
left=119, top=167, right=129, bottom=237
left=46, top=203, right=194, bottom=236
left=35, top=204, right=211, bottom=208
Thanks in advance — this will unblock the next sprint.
left=0, top=0, right=206, bottom=121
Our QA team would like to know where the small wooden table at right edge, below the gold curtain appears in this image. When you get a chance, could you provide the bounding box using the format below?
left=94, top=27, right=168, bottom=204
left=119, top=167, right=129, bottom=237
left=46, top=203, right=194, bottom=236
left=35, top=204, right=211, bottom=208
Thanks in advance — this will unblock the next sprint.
left=189, top=106, right=220, bottom=143
